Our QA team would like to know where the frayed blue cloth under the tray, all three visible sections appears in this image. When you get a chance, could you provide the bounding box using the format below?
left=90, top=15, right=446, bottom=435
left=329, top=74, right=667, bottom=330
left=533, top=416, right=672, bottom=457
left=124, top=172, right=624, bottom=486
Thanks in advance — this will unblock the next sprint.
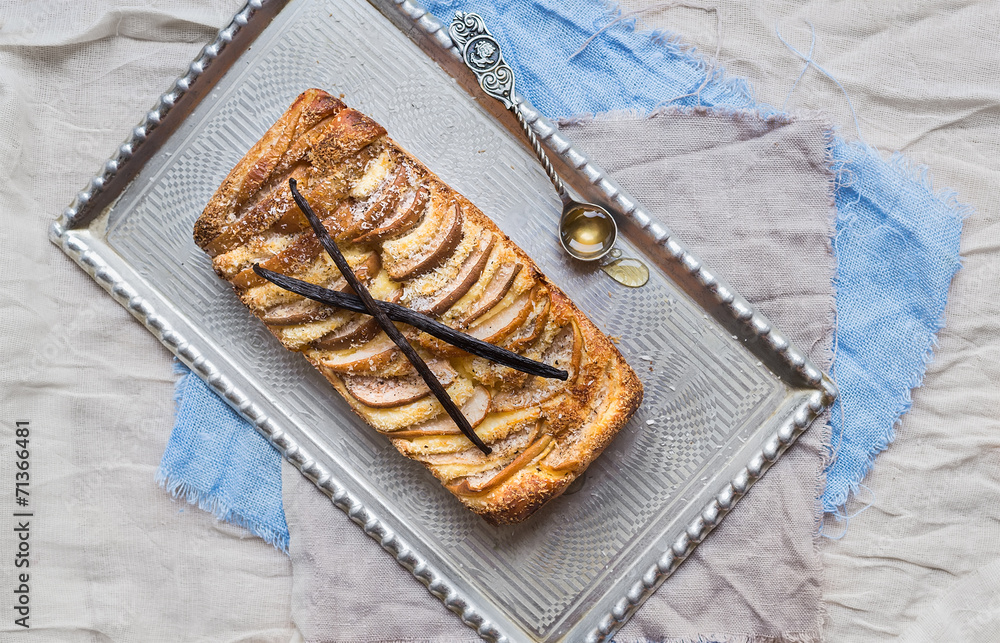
left=158, top=0, right=965, bottom=547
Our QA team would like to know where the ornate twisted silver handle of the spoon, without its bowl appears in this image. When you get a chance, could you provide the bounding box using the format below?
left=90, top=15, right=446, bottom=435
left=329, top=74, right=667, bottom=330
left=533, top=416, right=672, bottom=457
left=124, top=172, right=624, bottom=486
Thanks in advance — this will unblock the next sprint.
left=448, top=11, right=572, bottom=203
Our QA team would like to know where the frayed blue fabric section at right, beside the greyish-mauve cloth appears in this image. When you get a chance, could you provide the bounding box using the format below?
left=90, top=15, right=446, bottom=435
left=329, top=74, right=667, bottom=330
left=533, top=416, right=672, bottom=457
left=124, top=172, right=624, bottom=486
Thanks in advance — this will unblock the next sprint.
left=823, top=138, right=968, bottom=515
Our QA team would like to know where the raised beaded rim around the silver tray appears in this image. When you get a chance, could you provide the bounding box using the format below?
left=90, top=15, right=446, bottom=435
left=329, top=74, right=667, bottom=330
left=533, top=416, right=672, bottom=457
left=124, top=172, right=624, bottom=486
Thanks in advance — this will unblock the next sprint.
left=49, top=0, right=837, bottom=642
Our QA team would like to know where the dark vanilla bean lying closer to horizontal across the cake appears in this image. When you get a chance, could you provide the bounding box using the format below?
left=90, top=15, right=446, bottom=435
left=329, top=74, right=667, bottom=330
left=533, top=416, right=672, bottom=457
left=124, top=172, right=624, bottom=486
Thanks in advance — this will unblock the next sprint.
left=253, top=264, right=569, bottom=382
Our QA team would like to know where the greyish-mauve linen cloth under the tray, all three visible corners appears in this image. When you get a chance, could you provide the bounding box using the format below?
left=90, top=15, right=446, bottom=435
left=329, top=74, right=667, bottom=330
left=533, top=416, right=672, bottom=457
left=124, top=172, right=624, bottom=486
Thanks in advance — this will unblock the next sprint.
left=283, top=110, right=835, bottom=643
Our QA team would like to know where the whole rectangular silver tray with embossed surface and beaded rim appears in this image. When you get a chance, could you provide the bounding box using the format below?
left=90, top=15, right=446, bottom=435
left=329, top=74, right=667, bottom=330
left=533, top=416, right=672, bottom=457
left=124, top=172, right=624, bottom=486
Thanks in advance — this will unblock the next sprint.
left=51, top=0, right=835, bottom=641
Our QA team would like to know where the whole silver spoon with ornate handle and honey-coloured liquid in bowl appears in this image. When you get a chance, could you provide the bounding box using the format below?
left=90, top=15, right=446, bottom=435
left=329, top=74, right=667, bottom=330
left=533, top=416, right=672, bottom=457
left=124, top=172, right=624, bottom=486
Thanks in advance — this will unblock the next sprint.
left=448, top=11, right=618, bottom=261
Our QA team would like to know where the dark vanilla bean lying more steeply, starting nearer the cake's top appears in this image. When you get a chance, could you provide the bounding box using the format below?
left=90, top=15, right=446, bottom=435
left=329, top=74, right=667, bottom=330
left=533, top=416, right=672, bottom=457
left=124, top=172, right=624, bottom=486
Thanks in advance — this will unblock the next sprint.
left=288, top=179, right=493, bottom=455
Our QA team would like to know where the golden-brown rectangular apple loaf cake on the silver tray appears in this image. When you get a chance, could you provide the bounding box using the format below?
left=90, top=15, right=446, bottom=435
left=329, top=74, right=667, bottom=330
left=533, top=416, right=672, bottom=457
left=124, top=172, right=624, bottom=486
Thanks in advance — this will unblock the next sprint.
left=194, top=89, right=642, bottom=524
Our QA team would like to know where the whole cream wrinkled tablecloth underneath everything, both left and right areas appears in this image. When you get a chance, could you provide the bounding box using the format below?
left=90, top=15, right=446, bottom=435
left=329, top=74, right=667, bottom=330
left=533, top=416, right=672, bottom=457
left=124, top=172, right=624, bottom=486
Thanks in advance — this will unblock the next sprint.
left=0, top=0, right=1000, bottom=643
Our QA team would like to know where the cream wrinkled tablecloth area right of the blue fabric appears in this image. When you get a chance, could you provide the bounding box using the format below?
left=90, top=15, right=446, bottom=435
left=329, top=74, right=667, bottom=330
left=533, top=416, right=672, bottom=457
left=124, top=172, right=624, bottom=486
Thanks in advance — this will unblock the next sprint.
left=622, top=0, right=1000, bottom=643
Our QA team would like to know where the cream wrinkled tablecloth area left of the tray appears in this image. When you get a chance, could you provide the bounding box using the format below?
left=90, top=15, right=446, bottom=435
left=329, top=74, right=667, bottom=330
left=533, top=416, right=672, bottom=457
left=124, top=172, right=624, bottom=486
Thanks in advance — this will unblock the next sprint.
left=0, top=0, right=295, bottom=643
